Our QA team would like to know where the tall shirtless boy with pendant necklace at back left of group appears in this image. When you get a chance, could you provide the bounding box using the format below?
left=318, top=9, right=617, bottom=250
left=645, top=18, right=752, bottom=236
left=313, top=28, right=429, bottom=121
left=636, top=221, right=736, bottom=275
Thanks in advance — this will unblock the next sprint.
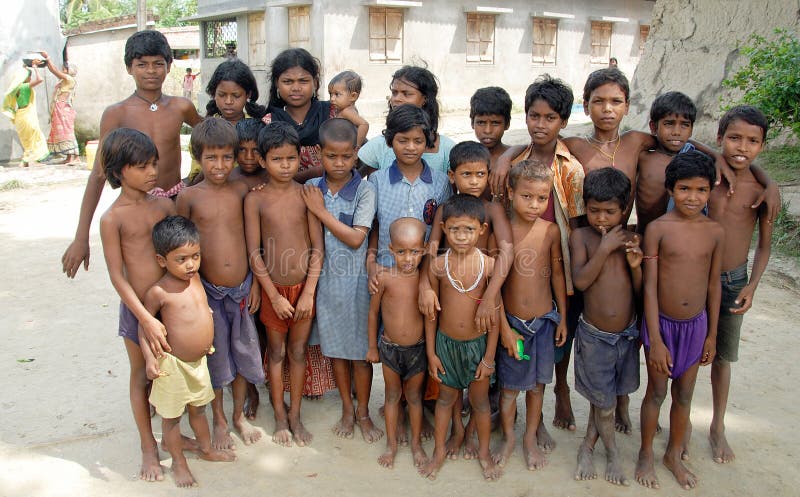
left=61, top=30, right=201, bottom=280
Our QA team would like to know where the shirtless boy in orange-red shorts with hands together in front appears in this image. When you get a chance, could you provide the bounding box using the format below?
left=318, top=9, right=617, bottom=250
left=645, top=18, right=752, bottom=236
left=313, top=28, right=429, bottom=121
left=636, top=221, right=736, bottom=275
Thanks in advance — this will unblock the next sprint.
left=244, top=122, right=323, bottom=447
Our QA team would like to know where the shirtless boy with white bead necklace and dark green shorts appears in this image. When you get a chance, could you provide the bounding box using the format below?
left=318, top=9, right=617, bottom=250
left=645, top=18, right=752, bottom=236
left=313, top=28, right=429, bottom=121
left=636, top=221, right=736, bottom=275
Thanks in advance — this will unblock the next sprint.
left=418, top=194, right=502, bottom=481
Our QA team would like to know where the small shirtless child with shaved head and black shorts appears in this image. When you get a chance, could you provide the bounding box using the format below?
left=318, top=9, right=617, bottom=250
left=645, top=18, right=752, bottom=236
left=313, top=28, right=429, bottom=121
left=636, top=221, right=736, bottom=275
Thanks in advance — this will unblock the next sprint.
left=367, top=217, right=428, bottom=469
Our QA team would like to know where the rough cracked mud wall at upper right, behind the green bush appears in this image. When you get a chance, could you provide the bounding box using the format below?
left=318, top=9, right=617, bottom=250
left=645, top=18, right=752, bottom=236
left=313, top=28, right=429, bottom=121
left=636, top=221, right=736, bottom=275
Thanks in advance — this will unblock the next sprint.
left=627, top=0, right=800, bottom=143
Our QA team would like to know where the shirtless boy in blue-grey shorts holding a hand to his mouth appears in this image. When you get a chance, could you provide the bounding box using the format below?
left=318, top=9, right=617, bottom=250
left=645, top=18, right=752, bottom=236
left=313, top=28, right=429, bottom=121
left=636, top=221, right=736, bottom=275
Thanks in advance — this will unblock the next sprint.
left=570, top=167, right=642, bottom=485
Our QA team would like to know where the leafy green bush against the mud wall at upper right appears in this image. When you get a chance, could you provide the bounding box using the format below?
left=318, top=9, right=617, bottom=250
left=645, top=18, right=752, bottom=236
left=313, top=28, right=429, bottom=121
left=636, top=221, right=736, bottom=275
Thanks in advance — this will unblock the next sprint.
left=722, top=29, right=800, bottom=138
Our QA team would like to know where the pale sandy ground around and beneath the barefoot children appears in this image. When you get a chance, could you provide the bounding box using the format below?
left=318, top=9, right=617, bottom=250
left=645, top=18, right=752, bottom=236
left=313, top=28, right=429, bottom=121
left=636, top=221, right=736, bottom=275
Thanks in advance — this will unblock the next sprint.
left=0, top=113, right=800, bottom=497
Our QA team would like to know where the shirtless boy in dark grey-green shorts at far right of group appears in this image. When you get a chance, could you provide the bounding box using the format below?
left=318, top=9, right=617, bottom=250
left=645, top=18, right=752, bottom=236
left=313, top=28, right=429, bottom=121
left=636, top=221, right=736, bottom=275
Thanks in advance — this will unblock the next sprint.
left=708, top=106, right=772, bottom=463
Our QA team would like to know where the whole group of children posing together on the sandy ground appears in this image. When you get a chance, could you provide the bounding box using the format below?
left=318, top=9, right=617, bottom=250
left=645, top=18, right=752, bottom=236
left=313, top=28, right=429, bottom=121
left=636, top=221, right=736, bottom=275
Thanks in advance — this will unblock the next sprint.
left=64, top=28, right=776, bottom=488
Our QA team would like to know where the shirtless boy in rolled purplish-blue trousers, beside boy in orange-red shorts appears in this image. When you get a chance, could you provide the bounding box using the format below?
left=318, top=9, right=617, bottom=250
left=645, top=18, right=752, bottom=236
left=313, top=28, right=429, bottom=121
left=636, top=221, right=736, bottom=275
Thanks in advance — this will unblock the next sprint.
left=177, top=117, right=264, bottom=449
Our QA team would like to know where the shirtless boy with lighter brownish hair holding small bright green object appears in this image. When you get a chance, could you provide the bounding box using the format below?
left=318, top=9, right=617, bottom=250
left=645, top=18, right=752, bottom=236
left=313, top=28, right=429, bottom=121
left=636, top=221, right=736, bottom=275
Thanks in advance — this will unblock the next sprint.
left=494, top=159, right=567, bottom=470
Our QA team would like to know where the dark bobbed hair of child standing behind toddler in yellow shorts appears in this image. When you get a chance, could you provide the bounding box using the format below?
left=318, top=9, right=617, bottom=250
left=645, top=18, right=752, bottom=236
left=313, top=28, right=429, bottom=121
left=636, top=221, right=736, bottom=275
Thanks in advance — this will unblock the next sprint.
left=100, top=128, right=158, bottom=188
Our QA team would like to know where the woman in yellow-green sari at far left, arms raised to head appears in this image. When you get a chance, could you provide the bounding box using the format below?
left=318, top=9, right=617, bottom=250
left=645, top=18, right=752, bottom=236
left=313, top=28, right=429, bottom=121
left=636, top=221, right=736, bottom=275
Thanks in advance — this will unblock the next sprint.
left=3, top=60, right=49, bottom=167
